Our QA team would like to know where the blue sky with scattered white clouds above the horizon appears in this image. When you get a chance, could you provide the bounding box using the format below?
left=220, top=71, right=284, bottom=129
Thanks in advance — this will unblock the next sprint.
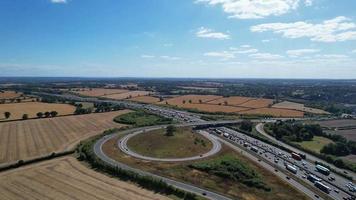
left=0, top=0, right=356, bottom=79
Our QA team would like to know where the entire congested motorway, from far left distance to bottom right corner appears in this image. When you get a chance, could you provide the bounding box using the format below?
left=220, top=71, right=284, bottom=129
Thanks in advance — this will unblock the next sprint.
left=35, top=93, right=355, bottom=200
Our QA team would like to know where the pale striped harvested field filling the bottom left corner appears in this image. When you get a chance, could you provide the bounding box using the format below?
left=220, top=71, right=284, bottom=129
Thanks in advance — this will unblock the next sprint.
left=0, top=157, right=169, bottom=200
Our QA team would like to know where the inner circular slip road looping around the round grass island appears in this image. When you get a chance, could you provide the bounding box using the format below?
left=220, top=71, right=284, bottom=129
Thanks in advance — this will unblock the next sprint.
left=118, top=128, right=221, bottom=162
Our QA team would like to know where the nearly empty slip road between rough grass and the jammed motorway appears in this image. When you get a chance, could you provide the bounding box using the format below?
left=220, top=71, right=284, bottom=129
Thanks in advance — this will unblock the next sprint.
left=214, top=138, right=323, bottom=200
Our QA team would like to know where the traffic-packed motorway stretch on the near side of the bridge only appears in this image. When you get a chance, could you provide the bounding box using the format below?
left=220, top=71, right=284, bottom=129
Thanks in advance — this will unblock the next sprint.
left=208, top=127, right=353, bottom=200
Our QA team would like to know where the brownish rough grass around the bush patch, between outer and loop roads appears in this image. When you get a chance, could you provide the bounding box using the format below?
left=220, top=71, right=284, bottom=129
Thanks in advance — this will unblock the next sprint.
left=103, top=136, right=308, bottom=200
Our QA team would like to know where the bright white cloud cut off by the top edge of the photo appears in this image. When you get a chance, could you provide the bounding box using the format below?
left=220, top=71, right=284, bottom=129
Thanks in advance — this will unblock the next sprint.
left=195, top=0, right=312, bottom=19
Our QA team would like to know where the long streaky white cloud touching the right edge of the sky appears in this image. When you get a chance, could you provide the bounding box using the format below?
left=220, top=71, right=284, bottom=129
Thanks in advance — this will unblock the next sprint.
left=250, top=16, right=356, bottom=42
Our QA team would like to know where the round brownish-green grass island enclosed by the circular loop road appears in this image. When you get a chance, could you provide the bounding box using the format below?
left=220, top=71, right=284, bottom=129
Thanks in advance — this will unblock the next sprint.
left=128, top=128, right=212, bottom=158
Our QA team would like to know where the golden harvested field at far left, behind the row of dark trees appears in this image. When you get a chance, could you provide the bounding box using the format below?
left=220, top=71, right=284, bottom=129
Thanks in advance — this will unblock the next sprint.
left=0, top=102, right=75, bottom=121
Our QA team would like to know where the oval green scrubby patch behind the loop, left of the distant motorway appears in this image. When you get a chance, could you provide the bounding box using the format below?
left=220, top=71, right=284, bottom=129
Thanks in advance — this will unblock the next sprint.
left=114, top=111, right=172, bottom=127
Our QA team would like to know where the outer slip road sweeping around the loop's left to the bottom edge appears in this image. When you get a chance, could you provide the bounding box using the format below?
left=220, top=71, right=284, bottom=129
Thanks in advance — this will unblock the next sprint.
left=94, top=126, right=231, bottom=200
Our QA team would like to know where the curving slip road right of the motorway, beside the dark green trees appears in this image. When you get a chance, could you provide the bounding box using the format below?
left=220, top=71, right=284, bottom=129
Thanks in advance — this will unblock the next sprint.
left=256, top=123, right=356, bottom=180
